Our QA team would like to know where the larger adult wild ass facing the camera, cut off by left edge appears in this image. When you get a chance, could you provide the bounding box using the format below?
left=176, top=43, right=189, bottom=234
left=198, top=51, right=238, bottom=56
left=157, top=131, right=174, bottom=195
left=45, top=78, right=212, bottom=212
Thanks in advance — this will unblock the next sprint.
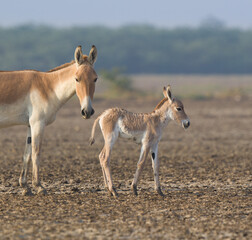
left=0, top=46, right=97, bottom=195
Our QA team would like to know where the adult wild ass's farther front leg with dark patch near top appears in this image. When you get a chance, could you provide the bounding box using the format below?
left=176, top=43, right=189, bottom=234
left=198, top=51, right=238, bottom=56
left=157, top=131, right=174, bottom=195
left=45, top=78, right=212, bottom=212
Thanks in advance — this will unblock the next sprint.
left=19, top=127, right=32, bottom=195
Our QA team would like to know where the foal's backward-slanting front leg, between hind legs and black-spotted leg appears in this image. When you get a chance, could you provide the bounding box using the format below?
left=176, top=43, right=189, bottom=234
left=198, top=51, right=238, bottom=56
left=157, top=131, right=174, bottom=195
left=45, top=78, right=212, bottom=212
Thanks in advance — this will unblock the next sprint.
left=131, top=145, right=150, bottom=196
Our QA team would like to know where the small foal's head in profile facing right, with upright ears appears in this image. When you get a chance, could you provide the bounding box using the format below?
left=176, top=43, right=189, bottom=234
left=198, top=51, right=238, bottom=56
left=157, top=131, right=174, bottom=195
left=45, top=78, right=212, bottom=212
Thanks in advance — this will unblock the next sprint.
left=160, top=85, right=190, bottom=129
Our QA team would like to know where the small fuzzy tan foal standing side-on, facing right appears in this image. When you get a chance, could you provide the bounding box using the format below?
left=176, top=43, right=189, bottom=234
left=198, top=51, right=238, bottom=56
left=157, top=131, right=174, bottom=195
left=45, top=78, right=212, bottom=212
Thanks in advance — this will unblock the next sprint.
left=90, top=85, right=190, bottom=197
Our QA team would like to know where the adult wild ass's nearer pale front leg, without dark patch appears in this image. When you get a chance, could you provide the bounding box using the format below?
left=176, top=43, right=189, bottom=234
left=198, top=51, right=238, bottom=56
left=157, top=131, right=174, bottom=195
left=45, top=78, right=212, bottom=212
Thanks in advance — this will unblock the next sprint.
left=31, top=121, right=47, bottom=195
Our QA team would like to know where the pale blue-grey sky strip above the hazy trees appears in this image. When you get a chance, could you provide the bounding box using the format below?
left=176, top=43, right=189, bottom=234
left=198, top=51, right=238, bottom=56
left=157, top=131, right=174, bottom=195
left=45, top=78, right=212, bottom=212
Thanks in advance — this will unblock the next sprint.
left=0, top=0, right=252, bottom=28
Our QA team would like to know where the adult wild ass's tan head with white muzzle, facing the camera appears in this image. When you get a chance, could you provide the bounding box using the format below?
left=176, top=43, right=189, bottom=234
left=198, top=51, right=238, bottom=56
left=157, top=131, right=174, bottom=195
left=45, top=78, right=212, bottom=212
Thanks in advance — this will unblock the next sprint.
left=74, top=45, right=98, bottom=119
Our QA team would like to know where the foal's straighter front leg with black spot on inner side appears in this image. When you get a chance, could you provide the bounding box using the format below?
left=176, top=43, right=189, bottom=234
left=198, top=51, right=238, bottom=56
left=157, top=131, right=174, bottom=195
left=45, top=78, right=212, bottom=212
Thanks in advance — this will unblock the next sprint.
left=150, top=143, right=164, bottom=196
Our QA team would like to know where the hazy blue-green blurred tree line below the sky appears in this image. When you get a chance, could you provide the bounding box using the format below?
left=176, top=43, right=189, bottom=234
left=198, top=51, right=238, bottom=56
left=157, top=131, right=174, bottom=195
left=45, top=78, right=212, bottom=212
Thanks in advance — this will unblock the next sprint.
left=0, top=24, right=252, bottom=74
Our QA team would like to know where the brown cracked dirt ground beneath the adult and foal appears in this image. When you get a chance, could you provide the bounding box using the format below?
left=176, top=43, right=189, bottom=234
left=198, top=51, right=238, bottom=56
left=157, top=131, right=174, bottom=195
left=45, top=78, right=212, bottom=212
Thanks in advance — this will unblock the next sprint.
left=0, top=96, right=252, bottom=239
